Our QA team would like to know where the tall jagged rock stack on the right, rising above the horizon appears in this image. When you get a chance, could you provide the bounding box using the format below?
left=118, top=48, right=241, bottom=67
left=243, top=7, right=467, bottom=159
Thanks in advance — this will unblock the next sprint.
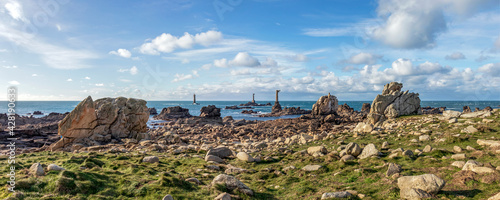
left=368, top=82, right=422, bottom=124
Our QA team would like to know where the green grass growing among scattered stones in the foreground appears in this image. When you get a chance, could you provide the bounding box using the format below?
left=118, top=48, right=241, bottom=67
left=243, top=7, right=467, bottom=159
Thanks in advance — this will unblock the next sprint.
left=0, top=111, right=500, bottom=199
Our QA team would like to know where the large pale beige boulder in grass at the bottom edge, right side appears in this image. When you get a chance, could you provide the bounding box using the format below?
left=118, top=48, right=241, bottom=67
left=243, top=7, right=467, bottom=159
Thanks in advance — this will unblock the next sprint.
left=398, top=174, right=446, bottom=199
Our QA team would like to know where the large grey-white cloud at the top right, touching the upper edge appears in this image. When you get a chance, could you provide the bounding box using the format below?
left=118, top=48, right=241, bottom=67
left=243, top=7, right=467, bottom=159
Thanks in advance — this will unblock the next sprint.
left=372, top=0, right=495, bottom=49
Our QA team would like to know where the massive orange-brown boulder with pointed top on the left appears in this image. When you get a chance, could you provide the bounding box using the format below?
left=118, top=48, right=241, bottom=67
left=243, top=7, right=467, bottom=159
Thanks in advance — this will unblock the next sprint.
left=51, top=96, right=149, bottom=150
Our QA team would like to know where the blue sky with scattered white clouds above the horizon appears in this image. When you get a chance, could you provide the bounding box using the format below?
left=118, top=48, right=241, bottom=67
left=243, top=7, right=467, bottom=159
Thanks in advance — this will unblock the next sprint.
left=0, top=0, right=500, bottom=101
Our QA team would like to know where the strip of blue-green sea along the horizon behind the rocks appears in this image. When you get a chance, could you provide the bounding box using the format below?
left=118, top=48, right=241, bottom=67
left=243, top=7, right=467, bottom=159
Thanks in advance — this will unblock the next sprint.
left=0, top=101, right=500, bottom=120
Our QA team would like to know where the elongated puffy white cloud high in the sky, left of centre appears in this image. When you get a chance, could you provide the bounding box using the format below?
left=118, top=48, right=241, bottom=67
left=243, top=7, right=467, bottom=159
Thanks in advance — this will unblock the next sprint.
left=139, top=31, right=222, bottom=55
